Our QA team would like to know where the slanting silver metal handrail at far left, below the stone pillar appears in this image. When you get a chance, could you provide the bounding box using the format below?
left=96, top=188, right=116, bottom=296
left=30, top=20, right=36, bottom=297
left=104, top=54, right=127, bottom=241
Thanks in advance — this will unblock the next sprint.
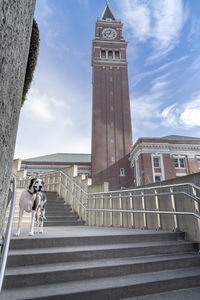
left=0, top=177, right=16, bottom=292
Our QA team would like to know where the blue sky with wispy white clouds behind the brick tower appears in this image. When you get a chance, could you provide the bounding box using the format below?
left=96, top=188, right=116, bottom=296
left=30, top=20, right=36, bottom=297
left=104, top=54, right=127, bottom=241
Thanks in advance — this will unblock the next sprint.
left=15, top=0, right=200, bottom=159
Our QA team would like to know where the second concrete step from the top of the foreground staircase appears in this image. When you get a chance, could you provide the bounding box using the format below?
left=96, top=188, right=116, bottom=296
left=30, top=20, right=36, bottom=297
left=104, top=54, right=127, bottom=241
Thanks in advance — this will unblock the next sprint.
left=7, top=241, right=195, bottom=267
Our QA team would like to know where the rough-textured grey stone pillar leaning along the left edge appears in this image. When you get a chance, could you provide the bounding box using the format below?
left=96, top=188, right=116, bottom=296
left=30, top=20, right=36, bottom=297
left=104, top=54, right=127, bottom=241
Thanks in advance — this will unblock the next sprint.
left=0, top=0, right=35, bottom=236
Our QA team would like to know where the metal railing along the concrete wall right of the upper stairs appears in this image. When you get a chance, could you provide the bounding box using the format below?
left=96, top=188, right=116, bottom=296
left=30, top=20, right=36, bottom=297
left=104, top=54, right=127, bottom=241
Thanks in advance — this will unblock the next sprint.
left=16, top=171, right=200, bottom=242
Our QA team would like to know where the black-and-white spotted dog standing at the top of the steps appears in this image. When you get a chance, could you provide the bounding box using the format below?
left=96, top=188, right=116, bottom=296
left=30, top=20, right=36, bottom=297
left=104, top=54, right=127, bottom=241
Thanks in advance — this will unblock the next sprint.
left=15, top=178, right=47, bottom=236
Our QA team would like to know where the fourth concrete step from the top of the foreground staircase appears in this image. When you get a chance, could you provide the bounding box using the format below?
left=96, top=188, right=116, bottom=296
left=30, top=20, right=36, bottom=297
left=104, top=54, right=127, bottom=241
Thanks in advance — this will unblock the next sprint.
left=1, top=267, right=200, bottom=300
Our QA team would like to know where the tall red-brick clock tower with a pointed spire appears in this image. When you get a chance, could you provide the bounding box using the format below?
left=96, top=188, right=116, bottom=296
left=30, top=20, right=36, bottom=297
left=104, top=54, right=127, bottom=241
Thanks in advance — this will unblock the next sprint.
left=92, top=2, right=132, bottom=190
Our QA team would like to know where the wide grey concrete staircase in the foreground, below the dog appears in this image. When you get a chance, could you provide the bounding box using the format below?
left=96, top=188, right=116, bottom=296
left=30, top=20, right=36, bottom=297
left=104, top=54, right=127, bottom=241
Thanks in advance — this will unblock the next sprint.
left=1, top=226, right=200, bottom=300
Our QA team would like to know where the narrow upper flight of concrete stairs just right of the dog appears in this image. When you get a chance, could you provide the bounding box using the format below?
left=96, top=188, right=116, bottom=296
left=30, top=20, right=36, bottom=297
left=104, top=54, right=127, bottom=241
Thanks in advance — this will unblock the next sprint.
left=44, top=192, right=84, bottom=227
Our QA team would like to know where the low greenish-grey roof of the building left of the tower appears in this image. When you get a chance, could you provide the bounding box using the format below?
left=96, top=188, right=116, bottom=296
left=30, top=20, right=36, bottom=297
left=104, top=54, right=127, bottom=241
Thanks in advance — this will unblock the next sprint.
left=23, top=153, right=91, bottom=163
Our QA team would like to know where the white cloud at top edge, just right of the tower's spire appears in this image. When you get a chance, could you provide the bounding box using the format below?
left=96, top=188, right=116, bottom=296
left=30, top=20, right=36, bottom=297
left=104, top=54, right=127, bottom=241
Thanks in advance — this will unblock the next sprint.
left=116, top=0, right=187, bottom=61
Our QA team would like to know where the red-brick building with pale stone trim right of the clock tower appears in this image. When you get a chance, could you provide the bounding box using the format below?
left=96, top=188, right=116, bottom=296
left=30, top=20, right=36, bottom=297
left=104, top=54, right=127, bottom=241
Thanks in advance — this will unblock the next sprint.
left=130, top=135, right=200, bottom=186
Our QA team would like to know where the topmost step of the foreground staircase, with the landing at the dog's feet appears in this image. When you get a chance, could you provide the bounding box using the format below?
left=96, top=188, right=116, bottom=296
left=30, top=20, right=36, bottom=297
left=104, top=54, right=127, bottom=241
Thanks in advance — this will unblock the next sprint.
left=10, top=232, right=184, bottom=253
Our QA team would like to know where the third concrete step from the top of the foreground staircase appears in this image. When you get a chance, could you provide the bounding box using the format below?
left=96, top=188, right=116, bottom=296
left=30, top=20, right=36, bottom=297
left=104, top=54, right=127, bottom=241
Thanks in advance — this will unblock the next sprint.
left=4, top=254, right=200, bottom=288
